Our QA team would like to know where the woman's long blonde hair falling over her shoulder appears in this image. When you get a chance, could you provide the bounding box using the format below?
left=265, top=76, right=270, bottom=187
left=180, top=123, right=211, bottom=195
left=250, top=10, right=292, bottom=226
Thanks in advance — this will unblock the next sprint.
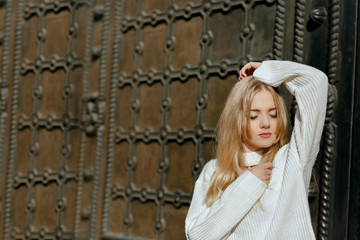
left=205, top=76, right=288, bottom=207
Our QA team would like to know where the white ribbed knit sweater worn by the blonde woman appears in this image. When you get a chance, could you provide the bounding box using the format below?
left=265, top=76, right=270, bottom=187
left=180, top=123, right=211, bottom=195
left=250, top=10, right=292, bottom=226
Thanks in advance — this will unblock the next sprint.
left=185, top=61, right=328, bottom=240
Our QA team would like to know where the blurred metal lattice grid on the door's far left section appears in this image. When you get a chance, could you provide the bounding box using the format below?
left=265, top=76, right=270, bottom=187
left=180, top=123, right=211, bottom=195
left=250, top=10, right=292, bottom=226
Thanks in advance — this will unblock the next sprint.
left=3, top=1, right=97, bottom=239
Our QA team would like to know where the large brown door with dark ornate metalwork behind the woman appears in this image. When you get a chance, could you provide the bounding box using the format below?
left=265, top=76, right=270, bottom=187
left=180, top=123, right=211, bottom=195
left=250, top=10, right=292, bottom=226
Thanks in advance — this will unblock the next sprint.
left=0, top=0, right=354, bottom=240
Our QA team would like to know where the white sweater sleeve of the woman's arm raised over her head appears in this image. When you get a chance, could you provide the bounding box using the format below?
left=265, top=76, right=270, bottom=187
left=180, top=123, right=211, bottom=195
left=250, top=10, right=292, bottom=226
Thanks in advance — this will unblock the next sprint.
left=254, top=61, right=328, bottom=169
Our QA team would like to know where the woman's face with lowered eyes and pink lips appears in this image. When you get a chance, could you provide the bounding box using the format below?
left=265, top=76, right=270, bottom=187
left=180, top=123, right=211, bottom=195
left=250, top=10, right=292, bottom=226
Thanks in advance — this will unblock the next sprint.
left=245, top=88, right=277, bottom=152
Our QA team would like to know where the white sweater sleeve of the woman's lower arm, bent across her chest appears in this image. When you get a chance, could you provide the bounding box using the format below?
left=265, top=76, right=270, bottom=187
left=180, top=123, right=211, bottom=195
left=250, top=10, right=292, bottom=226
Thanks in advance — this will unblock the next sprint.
left=185, top=160, right=266, bottom=240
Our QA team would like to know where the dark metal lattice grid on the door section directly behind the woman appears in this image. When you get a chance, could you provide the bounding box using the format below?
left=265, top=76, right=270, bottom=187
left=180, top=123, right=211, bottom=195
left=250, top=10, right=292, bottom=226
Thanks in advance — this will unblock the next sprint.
left=102, top=1, right=285, bottom=239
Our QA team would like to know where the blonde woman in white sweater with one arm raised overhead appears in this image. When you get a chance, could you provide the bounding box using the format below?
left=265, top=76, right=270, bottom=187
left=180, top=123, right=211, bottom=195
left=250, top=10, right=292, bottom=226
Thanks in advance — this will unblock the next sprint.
left=185, top=61, right=328, bottom=240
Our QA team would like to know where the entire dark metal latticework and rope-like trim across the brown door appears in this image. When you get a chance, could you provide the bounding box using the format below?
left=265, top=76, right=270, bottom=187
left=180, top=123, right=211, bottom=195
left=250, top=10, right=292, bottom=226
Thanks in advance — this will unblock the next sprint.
left=0, top=0, right=344, bottom=239
